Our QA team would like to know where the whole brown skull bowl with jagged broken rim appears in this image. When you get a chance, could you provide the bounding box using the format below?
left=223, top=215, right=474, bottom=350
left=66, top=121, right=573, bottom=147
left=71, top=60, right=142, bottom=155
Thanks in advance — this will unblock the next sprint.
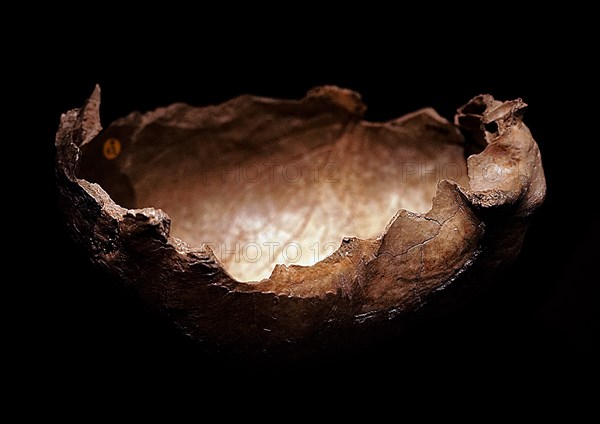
left=56, top=86, right=546, bottom=358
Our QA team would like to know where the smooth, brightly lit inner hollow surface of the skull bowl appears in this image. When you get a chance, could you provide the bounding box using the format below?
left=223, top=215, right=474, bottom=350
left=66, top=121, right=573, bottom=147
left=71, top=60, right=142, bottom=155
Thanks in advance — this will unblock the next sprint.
left=78, top=91, right=469, bottom=281
